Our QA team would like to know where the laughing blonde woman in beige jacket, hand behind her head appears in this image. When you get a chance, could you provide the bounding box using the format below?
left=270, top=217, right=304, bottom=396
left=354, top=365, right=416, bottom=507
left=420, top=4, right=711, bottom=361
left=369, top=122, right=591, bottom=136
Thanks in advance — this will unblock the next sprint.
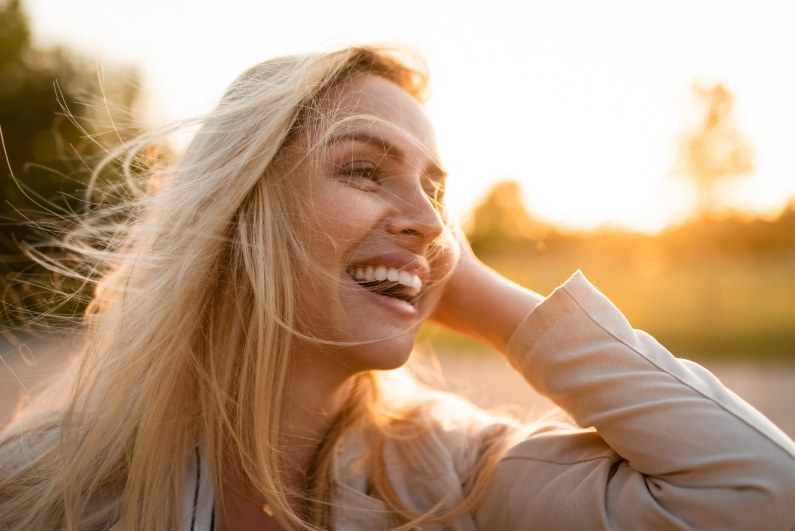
left=0, top=48, right=795, bottom=531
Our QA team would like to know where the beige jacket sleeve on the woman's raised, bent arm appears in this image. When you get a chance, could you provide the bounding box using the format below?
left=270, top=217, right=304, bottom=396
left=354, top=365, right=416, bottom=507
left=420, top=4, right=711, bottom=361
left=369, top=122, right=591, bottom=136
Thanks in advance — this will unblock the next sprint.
left=476, top=273, right=795, bottom=530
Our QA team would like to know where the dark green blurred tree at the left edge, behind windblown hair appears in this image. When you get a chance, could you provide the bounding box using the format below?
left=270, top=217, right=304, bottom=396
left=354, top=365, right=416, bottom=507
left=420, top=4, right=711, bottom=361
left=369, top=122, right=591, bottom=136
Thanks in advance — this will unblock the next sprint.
left=0, top=0, right=138, bottom=325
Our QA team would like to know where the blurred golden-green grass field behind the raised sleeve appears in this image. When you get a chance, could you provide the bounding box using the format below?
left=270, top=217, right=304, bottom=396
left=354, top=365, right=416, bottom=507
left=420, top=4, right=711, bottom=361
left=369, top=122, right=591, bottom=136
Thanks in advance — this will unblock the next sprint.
left=423, top=227, right=795, bottom=363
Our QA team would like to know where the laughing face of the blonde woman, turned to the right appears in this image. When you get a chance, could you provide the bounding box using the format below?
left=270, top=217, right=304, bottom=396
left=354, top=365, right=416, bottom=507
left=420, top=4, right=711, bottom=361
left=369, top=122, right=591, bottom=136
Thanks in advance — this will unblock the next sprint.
left=284, top=75, right=449, bottom=373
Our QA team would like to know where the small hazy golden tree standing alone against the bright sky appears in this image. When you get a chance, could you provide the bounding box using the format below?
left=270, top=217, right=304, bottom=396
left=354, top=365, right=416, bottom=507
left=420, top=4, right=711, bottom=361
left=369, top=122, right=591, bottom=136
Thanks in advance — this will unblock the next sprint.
left=677, top=83, right=754, bottom=216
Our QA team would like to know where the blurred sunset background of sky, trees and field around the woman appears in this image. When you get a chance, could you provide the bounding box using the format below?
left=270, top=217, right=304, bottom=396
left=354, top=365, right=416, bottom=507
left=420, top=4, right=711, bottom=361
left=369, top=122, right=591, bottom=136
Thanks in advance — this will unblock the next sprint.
left=0, top=0, right=795, bottom=435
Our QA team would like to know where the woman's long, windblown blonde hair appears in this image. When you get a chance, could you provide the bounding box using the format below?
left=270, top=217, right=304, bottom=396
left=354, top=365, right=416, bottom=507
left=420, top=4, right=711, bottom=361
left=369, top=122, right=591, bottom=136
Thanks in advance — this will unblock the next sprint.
left=0, top=47, right=502, bottom=530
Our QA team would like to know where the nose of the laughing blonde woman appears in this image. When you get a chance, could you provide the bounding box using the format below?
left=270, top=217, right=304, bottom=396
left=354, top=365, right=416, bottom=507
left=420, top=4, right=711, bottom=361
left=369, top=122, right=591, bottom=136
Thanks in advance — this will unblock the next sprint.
left=386, top=185, right=445, bottom=245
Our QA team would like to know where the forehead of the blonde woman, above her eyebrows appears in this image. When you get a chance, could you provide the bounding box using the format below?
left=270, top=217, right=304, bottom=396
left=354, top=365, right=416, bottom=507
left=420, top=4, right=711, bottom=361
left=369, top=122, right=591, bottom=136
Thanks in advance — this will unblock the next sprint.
left=316, top=74, right=438, bottom=159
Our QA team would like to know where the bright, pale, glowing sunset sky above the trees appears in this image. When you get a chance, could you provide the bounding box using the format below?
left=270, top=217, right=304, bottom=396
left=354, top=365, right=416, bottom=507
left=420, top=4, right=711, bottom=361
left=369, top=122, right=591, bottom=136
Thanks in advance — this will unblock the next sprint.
left=25, top=0, right=795, bottom=231
